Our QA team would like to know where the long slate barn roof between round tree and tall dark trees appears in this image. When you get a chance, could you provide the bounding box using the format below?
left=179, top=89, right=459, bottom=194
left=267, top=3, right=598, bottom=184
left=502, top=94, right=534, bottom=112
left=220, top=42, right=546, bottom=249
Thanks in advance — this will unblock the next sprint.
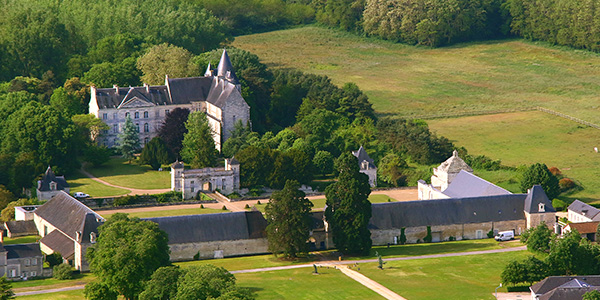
left=144, top=211, right=267, bottom=244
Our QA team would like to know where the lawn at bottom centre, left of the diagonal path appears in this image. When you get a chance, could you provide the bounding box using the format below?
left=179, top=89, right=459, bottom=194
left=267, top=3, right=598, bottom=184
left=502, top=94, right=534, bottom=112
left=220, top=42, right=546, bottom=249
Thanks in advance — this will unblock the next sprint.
left=235, top=268, right=384, bottom=300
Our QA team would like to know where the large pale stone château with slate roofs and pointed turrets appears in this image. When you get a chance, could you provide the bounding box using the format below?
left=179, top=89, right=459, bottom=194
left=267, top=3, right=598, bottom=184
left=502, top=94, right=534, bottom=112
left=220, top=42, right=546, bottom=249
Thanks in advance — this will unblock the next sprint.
left=89, top=51, right=250, bottom=151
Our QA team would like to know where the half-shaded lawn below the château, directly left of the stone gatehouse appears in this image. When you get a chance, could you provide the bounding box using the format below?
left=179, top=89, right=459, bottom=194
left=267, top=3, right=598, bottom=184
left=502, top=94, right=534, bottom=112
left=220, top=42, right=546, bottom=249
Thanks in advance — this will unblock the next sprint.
left=86, top=158, right=171, bottom=189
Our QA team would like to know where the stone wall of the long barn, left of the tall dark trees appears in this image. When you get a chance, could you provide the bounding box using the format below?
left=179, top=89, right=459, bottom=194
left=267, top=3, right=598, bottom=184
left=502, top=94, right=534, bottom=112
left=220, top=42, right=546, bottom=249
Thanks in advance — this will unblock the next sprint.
left=169, top=238, right=268, bottom=261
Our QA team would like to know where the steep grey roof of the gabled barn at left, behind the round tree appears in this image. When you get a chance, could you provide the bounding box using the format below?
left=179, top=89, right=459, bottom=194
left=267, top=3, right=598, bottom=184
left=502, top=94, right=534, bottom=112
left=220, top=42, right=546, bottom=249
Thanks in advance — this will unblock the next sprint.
left=34, top=192, right=104, bottom=241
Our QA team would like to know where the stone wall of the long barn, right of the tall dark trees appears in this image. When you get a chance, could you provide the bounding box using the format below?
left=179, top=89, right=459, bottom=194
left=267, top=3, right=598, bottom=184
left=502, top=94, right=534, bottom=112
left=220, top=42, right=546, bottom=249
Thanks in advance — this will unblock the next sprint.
left=371, top=220, right=526, bottom=245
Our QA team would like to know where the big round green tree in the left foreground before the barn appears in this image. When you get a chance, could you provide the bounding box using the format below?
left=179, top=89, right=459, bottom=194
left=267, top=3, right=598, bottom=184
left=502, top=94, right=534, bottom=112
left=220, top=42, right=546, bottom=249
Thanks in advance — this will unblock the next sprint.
left=87, top=214, right=170, bottom=299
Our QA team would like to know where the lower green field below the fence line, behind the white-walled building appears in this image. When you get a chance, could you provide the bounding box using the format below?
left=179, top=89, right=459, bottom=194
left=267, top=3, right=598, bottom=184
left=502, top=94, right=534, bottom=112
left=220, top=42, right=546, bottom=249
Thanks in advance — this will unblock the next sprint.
left=428, top=112, right=600, bottom=202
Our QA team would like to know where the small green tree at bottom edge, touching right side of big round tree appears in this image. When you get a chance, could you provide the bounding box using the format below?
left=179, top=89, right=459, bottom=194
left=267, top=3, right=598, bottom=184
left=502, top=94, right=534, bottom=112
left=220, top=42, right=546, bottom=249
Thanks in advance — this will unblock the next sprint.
left=140, top=266, right=184, bottom=300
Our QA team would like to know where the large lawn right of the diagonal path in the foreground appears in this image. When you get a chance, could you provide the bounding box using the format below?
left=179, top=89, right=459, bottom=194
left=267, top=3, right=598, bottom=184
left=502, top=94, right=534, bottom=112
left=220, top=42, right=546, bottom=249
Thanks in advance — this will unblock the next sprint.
left=359, top=251, right=531, bottom=300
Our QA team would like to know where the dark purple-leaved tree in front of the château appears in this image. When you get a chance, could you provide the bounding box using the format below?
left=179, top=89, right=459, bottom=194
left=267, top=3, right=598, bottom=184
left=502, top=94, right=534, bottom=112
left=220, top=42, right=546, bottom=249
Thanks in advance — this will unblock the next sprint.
left=158, top=107, right=190, bottom=159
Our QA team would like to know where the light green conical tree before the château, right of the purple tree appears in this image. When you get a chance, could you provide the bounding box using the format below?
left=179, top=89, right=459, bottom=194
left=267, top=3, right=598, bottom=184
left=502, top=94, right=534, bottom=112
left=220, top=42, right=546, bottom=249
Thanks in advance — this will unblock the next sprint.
left=181, top=112, right=219, bottom=168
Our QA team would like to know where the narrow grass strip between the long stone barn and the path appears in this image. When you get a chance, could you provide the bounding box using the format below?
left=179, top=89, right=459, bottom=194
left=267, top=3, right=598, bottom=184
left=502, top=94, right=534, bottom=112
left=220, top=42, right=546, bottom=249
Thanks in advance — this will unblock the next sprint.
left=176, top=239, right=522, bottom=271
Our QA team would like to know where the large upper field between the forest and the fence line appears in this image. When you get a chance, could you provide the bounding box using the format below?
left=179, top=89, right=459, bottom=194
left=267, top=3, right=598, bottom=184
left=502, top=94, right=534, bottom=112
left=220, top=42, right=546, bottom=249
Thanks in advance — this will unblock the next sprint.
left=233, top=26, right=600, bottom=124
